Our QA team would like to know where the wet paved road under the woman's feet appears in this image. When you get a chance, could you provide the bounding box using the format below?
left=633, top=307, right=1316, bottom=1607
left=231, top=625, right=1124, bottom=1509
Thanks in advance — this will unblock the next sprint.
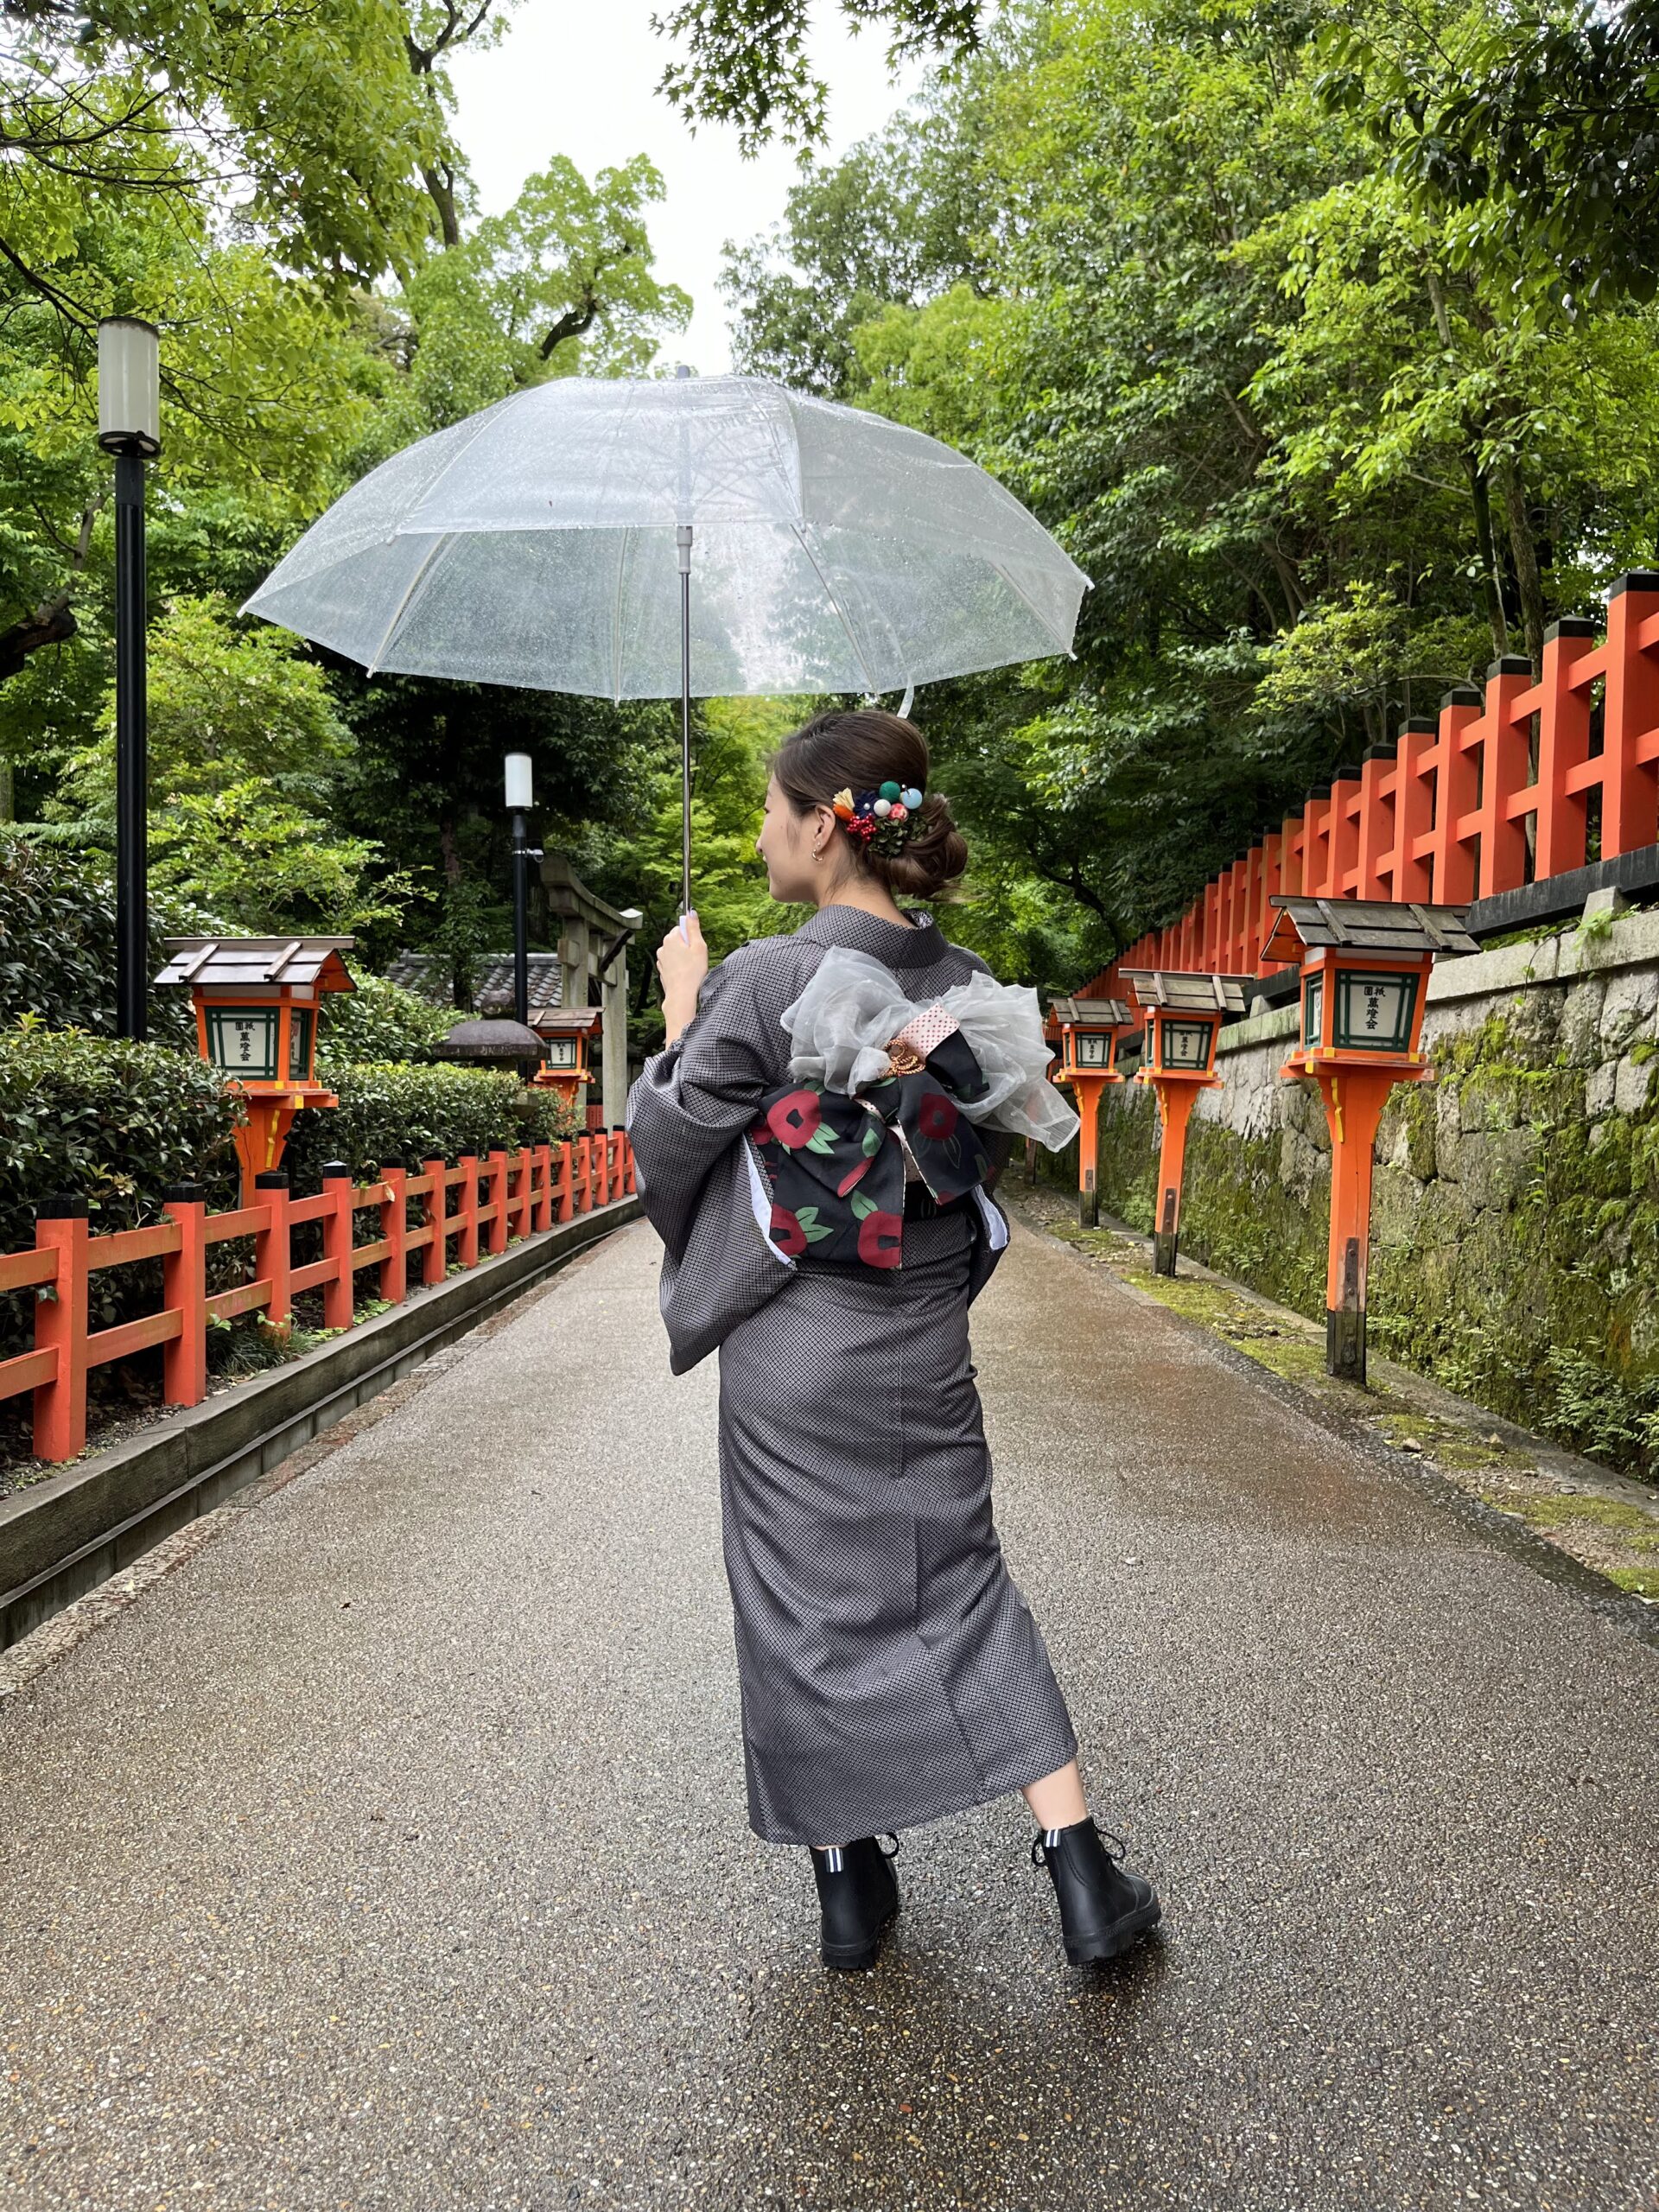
left=0, top=1228, right=1659, bottom=2212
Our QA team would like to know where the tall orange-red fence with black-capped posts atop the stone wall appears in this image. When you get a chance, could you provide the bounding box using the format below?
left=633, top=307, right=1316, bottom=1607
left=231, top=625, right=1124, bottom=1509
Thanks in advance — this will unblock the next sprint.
left=1082, top=570, right=1659, bottom=998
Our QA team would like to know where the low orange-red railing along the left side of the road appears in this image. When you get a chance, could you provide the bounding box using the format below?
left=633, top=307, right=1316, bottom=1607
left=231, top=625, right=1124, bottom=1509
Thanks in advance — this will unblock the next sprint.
left=0, top=1128, right=635, bottom=1460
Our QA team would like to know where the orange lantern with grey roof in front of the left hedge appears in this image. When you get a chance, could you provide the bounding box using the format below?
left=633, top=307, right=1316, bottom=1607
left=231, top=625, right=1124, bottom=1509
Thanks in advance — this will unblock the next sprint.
left=155, top=938, right=356, bottom=1205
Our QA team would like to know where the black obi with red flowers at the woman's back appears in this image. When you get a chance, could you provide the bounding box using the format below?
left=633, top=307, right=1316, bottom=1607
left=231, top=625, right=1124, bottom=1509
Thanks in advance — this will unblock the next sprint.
left=750, top=1028, right=991, bottom=1268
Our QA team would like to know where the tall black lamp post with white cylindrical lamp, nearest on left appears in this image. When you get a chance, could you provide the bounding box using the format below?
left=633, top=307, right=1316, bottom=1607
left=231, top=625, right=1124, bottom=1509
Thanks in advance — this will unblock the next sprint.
left=98, top=315, right=162, bottom=1038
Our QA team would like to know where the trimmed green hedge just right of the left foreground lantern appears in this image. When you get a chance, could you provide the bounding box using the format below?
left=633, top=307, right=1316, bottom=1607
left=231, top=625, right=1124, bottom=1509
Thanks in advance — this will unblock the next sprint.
left=283, top=1055, right=582, bottom=1192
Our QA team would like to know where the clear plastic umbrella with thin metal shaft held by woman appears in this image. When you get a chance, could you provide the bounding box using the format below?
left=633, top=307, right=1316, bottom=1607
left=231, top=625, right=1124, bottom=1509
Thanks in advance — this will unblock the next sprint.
left=244, top=374, right=1089, bottom=907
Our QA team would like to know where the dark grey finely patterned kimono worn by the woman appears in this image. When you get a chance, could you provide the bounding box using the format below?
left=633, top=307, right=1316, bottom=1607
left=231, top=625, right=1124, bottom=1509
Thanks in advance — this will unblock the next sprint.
left=628, top=907, right=1077, bottom=1845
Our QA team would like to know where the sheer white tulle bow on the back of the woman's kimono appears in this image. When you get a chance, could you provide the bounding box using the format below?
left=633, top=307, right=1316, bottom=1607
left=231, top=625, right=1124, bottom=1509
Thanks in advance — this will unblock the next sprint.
left=783, top=944, right=1079, bottom=1153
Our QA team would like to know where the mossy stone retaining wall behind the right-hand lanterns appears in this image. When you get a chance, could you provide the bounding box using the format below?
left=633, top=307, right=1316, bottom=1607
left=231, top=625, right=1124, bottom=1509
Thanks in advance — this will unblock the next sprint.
left=1099, top=912, right=1659, bottom=1473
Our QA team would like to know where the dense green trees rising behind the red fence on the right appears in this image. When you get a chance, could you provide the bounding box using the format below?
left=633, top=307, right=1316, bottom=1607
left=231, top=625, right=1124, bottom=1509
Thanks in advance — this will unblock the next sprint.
left=728, top=0, right=1659, bottom=984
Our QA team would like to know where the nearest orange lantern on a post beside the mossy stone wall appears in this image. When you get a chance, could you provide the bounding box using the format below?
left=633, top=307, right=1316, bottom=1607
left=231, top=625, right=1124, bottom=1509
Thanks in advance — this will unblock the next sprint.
left=1261, top=892, right=1480, bottom=1382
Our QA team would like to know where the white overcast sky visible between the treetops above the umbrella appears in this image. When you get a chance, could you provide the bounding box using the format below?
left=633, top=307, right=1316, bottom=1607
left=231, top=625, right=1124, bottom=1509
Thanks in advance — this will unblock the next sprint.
left=454, top=0, right=923, bottom=376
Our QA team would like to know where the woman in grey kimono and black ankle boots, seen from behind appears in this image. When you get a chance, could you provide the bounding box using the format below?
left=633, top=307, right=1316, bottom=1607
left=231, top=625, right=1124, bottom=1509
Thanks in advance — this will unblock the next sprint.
left=628, top=710, right=1159, bottom=1968
